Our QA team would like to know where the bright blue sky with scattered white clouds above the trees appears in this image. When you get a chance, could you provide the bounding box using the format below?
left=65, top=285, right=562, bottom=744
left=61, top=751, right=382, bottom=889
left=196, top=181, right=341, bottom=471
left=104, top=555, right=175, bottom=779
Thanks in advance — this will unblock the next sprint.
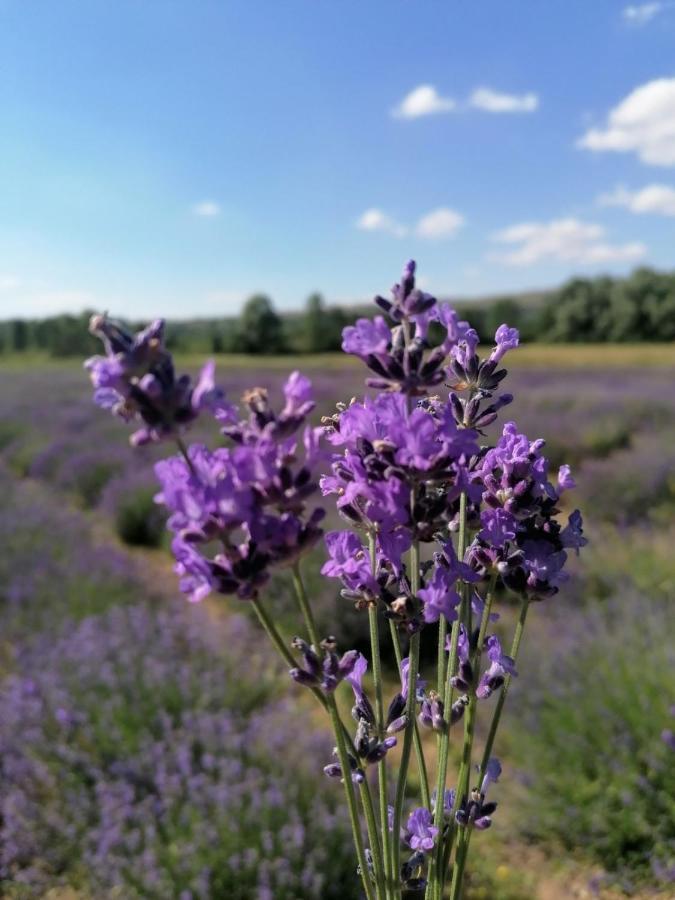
left=0, top=0, right=675, bottom=318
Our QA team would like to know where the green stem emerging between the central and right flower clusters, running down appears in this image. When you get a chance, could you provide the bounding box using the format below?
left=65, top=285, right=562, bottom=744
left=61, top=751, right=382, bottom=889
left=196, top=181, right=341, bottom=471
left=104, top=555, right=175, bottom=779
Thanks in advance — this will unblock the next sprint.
left=426, top=492, right=467, bottom=900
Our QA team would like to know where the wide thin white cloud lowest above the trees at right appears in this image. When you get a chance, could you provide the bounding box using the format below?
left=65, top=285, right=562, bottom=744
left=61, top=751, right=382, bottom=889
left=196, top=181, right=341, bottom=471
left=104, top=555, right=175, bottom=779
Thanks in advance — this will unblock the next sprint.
left=491, top=219, right=647, bottom=266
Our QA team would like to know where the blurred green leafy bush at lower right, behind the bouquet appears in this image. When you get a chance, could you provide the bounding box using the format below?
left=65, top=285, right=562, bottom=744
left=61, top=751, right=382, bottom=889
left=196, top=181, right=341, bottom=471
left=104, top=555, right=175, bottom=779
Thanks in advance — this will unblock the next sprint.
left=511, top=595, right=675, bottom=887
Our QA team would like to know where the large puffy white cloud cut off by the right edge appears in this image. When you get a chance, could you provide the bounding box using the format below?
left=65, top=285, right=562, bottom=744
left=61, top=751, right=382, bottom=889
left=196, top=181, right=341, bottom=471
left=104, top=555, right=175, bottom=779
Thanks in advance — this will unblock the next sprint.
left=577, top=78, right=675, bottom=166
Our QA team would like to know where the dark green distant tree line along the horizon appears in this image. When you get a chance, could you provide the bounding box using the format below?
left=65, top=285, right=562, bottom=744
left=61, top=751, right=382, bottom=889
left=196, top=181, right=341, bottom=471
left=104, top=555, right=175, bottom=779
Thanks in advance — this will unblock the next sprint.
left=0, top=268, right=675, bottom=357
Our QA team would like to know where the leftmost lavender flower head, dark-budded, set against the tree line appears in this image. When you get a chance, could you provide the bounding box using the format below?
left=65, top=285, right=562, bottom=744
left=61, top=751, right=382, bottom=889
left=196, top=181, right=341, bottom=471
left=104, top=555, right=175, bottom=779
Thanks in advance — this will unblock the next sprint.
left=85, top=315, right=232, bottom=446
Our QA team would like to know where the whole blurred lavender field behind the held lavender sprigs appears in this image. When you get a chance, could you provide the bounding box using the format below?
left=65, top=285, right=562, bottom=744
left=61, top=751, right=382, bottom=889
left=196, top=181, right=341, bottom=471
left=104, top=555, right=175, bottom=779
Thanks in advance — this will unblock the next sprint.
left=0, top=348, right=675, bottom=900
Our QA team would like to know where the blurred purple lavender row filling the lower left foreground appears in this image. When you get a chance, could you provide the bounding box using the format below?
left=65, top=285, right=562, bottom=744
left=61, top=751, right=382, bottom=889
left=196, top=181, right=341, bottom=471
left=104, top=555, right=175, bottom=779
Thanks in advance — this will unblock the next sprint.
left=0, top=473, right=355, bottom=900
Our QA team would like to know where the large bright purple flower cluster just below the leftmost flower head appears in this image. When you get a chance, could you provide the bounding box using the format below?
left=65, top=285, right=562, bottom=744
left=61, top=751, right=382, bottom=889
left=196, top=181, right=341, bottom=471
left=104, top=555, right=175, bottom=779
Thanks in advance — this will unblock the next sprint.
left=155, top=372, right=324, bottom=601
